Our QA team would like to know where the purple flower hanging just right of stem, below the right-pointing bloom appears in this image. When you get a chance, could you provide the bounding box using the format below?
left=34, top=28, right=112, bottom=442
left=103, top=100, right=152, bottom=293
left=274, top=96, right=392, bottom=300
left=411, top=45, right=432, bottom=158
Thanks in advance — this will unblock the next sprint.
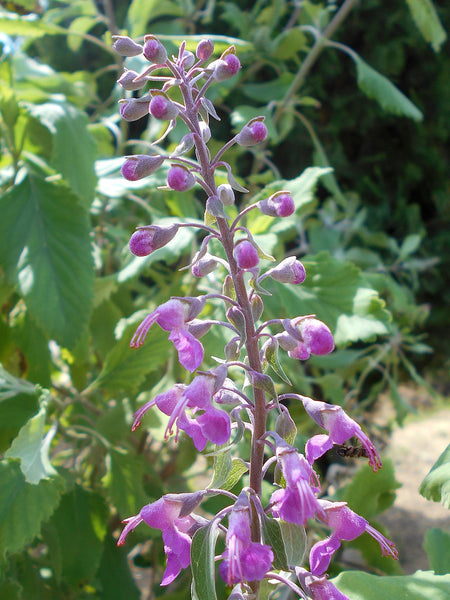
left=270, top=443, right=325, bottom=525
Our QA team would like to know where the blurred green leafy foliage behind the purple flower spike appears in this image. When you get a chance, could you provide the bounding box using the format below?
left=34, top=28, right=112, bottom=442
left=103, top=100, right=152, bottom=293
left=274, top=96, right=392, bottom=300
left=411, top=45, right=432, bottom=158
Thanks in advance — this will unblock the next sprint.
left=0, top=0, right=450, bottom=600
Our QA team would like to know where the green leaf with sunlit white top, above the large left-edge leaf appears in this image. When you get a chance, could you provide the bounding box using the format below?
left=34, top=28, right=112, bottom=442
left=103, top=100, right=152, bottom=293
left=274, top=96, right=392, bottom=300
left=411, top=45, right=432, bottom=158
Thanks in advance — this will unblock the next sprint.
left=31, top=102, right=97, bottom=209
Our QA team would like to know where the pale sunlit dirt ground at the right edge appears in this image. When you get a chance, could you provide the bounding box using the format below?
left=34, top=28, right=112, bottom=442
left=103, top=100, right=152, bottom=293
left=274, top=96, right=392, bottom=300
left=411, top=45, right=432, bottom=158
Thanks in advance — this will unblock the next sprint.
left=379, top=400, right=450, bottom=574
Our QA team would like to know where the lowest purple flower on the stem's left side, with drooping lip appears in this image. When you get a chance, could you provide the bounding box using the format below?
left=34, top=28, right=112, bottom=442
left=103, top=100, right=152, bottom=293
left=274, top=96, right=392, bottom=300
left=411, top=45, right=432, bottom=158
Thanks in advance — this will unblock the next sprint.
left=117, top=494, right=196, bottom=585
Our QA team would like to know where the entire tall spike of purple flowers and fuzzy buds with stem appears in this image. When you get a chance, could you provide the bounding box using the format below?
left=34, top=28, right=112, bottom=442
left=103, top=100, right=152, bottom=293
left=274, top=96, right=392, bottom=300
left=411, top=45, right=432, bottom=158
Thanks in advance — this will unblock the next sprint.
left=114, top=35, right=397, bottom=600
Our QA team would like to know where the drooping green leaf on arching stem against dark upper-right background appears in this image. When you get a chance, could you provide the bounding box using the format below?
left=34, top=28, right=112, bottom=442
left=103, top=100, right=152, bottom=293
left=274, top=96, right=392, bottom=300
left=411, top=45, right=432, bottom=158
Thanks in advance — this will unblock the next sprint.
left=351, top=52, right=423, bottom=121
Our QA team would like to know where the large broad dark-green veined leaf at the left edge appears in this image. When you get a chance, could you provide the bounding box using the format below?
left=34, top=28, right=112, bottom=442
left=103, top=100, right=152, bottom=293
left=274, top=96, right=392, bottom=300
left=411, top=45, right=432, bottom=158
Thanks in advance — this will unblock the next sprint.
left=0, top=175, right=94, bottom=347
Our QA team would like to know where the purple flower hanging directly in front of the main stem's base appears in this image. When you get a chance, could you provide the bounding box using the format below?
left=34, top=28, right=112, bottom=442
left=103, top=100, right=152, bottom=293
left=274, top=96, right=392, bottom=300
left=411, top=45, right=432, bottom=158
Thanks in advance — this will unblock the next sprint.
left=219, top=492, right=274, bottom=585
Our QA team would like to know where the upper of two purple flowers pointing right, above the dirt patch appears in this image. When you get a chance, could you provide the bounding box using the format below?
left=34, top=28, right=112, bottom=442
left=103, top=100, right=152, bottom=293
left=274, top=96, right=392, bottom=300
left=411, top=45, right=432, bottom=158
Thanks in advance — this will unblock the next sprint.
left=302, top=396, right=382, bottom=471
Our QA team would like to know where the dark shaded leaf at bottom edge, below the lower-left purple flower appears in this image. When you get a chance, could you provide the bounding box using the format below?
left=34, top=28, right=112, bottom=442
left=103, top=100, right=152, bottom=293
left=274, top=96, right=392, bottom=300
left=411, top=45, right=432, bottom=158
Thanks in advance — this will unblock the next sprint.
left=97, top=535, right=141, bottom=600
